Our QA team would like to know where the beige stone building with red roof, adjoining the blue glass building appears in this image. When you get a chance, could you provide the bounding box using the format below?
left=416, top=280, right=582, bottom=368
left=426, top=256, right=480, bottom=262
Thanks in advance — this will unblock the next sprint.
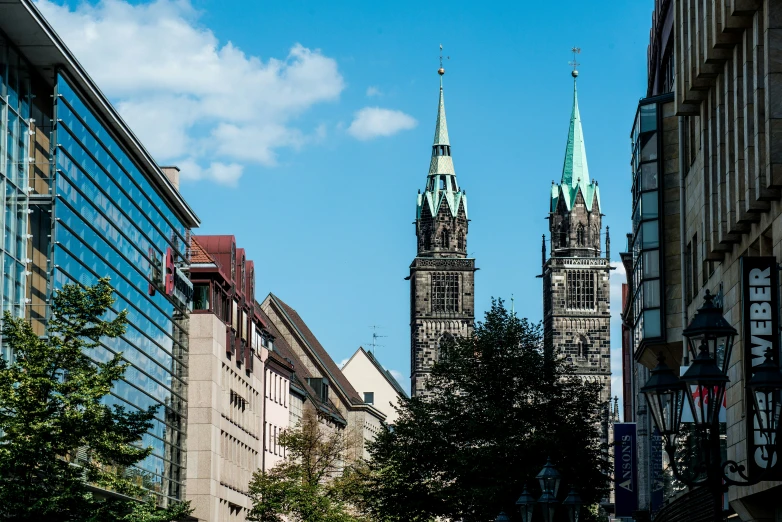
left=187, top=236, right=270, bottom=522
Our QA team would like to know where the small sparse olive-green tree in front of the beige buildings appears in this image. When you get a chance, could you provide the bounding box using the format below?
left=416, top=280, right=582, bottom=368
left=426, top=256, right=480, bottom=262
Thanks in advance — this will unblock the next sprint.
left=247, top=408, right=370, bottom=522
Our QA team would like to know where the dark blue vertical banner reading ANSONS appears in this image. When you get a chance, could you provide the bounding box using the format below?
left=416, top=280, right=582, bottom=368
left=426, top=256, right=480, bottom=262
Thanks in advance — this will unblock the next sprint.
left=614, top=422, right=638, bottom=517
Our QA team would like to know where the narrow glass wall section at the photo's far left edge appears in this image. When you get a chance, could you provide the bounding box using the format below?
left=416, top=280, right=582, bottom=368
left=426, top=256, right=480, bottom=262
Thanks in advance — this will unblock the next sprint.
left=0, top=35, right=31, bottom=358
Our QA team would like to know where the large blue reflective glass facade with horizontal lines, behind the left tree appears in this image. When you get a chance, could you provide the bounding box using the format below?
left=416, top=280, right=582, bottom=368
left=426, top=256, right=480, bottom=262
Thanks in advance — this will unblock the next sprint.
left=52, top=74, right=188, bottom=504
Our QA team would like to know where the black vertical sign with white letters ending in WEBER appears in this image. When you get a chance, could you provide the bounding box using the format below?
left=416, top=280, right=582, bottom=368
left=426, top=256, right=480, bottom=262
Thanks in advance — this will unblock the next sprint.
left=741, top=257, right=782, bottom=479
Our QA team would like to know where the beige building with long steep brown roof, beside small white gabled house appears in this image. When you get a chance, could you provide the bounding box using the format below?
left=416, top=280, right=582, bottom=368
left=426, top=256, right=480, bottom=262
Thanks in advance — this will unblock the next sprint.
left=261, top=294, right=386, bottom=460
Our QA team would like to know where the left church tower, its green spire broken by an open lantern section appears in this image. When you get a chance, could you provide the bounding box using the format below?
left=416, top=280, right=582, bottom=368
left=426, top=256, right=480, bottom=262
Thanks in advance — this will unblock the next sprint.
left=407, top=59, right=476, bottom=396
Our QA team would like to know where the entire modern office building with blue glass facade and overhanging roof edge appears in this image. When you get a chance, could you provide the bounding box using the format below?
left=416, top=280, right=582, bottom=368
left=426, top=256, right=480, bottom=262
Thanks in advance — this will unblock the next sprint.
left=0, top=0, right=198, bottom=505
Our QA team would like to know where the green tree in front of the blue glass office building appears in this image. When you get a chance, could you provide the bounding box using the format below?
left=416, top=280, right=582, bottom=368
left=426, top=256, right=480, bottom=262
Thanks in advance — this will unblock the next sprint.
left=0, top=279, right=190, bottom=522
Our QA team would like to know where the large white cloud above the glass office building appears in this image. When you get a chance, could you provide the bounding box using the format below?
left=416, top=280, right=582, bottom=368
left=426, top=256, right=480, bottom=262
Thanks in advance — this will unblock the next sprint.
left=37, top=0, right=345, bottom=185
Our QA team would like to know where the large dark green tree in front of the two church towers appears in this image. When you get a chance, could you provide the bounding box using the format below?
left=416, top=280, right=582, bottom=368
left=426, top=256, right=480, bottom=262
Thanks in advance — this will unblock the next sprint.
left=355, top=301, right=609, bottom=522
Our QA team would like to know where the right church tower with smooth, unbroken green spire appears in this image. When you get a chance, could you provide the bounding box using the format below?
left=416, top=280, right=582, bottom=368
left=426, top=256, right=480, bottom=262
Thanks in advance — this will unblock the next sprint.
left=543, top=74, right=611, bottom=403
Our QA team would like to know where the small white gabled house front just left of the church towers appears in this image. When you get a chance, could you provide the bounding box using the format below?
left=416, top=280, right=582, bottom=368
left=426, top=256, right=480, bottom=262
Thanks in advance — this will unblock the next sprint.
left=342, top=347, right=407, bottom=425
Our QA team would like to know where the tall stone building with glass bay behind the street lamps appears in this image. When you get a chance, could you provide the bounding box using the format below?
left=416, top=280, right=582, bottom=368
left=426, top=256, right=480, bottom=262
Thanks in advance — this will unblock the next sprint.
left=623, top=0, right=782, bottom=522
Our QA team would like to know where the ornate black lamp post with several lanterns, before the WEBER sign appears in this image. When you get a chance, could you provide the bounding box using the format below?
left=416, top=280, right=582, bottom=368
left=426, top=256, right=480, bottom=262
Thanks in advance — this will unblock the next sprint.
left=641, top=291, right=782, bottom=520
